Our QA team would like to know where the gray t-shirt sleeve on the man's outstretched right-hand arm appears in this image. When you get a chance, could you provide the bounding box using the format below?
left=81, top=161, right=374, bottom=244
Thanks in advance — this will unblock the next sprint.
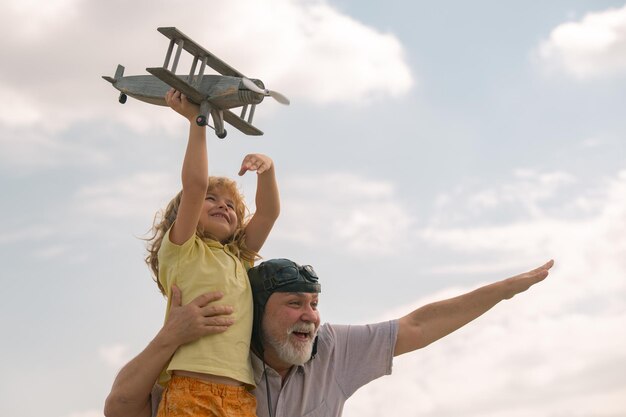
left=329, top=320, right=398, bottom=398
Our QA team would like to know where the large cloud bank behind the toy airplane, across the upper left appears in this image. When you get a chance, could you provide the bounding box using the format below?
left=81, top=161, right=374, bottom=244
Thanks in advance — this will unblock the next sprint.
left=0, top=0, right=413, bottom=130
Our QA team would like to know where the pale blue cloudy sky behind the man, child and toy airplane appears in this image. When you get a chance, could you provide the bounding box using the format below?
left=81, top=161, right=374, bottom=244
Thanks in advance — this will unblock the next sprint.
left=0, top=0, right=626, bottom=417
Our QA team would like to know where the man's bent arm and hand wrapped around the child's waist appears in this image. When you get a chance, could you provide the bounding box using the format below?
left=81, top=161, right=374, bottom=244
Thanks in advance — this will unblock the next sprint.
left=104, top=286, right=233, bottom=417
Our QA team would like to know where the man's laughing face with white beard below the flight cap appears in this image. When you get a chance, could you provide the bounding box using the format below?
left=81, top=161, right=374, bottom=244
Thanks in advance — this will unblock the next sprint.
left=262, top=292, right=320, bottom=367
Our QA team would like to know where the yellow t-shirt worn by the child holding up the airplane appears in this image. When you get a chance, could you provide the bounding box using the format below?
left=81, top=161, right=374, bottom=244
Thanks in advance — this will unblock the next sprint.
left=158, top=231, right=255, bottom=387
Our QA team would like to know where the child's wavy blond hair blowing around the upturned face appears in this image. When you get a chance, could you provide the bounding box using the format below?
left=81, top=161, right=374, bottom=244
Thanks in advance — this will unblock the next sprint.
left=145, top=177, right=259, bottom=294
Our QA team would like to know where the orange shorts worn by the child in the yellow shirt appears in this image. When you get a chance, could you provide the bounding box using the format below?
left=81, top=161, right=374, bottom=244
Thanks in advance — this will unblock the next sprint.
left=157, top=375, right=256, bottom=417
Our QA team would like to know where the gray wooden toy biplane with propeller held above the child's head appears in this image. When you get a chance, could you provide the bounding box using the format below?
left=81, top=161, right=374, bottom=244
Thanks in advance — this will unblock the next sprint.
left=102, top=27, right=289, bottom=139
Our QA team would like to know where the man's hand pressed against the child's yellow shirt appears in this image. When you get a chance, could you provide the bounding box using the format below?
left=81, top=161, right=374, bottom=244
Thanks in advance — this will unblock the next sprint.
left=161, top=285, right=234, bottom=346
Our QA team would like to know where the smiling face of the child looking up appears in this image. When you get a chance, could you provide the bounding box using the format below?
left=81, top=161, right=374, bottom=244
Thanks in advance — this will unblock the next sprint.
left=199, top=188, right=237, bottom=242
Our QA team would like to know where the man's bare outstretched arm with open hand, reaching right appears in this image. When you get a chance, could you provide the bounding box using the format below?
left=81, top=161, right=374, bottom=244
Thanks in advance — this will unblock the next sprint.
left=394, top=260, right=554, bottom=356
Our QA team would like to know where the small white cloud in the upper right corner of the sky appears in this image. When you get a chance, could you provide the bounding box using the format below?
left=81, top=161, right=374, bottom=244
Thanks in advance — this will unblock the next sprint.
left=535, top=6, right=626, bottom=80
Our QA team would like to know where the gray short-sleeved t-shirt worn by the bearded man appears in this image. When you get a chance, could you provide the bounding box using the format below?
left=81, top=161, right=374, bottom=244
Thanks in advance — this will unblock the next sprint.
left=152, top=320, right=398, bottom=417
